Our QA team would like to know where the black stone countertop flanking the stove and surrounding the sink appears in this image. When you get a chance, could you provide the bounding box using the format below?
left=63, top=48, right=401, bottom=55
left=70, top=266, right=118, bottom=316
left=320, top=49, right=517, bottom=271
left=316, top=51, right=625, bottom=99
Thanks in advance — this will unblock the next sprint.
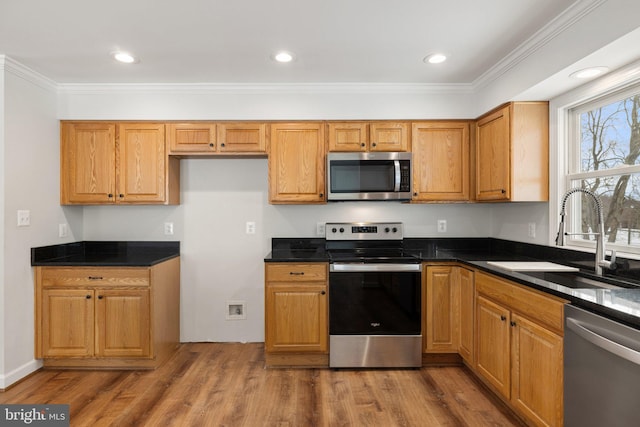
left=264, top=238, right=640, bottom=329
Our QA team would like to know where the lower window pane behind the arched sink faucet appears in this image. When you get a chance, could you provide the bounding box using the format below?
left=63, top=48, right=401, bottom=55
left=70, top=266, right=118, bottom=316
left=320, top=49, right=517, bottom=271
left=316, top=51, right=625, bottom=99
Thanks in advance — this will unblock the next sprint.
left=571, top=174, right=640, bottom=247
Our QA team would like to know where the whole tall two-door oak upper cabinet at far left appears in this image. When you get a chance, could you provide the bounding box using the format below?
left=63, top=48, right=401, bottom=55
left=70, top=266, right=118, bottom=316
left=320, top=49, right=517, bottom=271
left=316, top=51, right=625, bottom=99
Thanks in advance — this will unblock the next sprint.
left=60, top=122, right=180, bottom=205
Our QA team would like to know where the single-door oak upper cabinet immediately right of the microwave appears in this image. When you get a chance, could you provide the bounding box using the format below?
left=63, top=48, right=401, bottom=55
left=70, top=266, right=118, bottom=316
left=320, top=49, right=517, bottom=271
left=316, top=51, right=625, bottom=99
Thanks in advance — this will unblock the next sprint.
left=411, top=122, right=469, bottom=201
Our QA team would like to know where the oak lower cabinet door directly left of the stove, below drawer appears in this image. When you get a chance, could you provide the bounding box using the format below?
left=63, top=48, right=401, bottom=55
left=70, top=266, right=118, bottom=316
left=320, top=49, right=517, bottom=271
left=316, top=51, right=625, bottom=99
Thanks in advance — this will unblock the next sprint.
left=265, top=282, right=329, bottom=352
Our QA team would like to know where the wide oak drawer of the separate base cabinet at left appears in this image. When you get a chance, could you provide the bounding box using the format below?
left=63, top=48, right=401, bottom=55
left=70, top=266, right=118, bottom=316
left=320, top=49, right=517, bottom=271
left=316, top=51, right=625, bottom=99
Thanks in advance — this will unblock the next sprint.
left=42, top=267, right=149, bottom=287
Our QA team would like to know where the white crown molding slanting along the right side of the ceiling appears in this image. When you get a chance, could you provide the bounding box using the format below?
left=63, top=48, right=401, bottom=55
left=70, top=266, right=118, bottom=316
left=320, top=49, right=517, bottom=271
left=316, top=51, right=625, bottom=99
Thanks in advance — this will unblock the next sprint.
left=471, top=0, right=607, bottom=92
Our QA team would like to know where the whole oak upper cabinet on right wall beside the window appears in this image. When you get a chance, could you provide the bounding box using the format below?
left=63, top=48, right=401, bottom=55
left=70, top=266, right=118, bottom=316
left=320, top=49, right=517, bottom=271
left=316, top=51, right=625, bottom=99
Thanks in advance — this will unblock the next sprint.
left=476, top=102, right=549, bottom=201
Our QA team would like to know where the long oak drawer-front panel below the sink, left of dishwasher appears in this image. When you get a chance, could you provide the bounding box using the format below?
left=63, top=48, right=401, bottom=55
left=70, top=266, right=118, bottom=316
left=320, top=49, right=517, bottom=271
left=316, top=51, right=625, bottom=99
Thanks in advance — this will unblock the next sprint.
left=476, top=273, right=566, bottom=335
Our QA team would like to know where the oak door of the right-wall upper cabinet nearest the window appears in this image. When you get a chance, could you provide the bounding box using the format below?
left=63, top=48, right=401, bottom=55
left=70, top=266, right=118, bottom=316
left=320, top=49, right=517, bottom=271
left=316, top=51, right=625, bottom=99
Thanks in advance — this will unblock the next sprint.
left=476, top=106, right=511, bottom=200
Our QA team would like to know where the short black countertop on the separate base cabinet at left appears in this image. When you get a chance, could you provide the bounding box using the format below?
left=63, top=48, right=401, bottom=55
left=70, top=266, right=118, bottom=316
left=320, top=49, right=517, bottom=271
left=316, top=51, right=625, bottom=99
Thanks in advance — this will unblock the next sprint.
left=31, top=241, right=180, bottom=267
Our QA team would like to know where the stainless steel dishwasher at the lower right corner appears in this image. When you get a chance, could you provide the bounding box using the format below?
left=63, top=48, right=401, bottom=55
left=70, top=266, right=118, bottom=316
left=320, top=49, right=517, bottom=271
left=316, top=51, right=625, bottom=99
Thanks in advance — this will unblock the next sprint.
left=564, top=305, right=640, bottom=427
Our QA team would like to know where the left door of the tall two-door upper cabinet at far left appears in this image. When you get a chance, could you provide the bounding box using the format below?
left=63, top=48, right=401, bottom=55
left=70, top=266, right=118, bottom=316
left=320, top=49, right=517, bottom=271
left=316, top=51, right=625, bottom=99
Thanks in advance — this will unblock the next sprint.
left=60, top=123, right=116, bottom=205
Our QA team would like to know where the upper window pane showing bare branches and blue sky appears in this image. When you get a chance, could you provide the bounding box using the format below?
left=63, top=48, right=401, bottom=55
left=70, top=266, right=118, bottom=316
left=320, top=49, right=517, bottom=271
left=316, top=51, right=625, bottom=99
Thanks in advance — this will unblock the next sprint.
left=580, top=94, right=640, bottom=172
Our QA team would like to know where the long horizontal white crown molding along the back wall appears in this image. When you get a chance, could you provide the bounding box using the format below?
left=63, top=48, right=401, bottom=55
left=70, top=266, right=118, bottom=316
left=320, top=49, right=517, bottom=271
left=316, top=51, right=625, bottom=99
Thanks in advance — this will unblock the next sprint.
left=58, top=83, right=472, bottom=95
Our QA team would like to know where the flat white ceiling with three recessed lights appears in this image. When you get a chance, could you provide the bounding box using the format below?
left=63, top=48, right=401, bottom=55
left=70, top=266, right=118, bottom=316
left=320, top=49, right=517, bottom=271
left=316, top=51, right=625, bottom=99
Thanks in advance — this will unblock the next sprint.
left=0, top=0, right=575, bottom=85
